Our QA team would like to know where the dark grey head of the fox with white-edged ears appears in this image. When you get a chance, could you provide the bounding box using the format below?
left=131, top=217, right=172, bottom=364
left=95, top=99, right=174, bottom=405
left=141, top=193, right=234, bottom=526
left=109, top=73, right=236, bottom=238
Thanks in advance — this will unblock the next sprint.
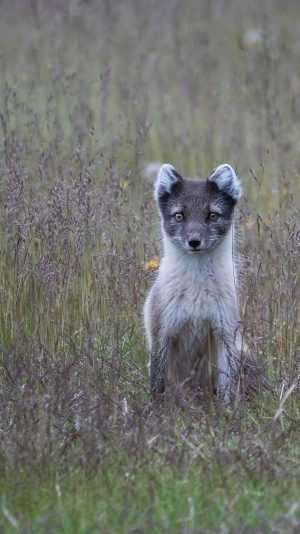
left=155, top=163, right=242, bottom=254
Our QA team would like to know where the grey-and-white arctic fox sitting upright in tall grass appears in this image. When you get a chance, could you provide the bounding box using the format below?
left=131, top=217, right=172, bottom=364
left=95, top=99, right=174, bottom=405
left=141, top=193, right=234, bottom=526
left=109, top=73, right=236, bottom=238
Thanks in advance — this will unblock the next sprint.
left=144, top=163, right=242, bottom=400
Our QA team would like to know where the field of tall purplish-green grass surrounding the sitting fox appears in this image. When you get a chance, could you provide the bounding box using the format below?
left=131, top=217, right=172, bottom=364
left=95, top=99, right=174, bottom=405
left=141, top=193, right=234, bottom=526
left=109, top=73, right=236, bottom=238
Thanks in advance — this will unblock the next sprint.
left=0, top=0, right=300, bottom=534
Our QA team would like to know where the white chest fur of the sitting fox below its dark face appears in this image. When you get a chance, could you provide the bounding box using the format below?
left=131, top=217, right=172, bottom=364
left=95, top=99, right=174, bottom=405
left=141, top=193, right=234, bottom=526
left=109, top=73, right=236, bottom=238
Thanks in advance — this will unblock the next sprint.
left=157, top=232, right=235, bottom=335
